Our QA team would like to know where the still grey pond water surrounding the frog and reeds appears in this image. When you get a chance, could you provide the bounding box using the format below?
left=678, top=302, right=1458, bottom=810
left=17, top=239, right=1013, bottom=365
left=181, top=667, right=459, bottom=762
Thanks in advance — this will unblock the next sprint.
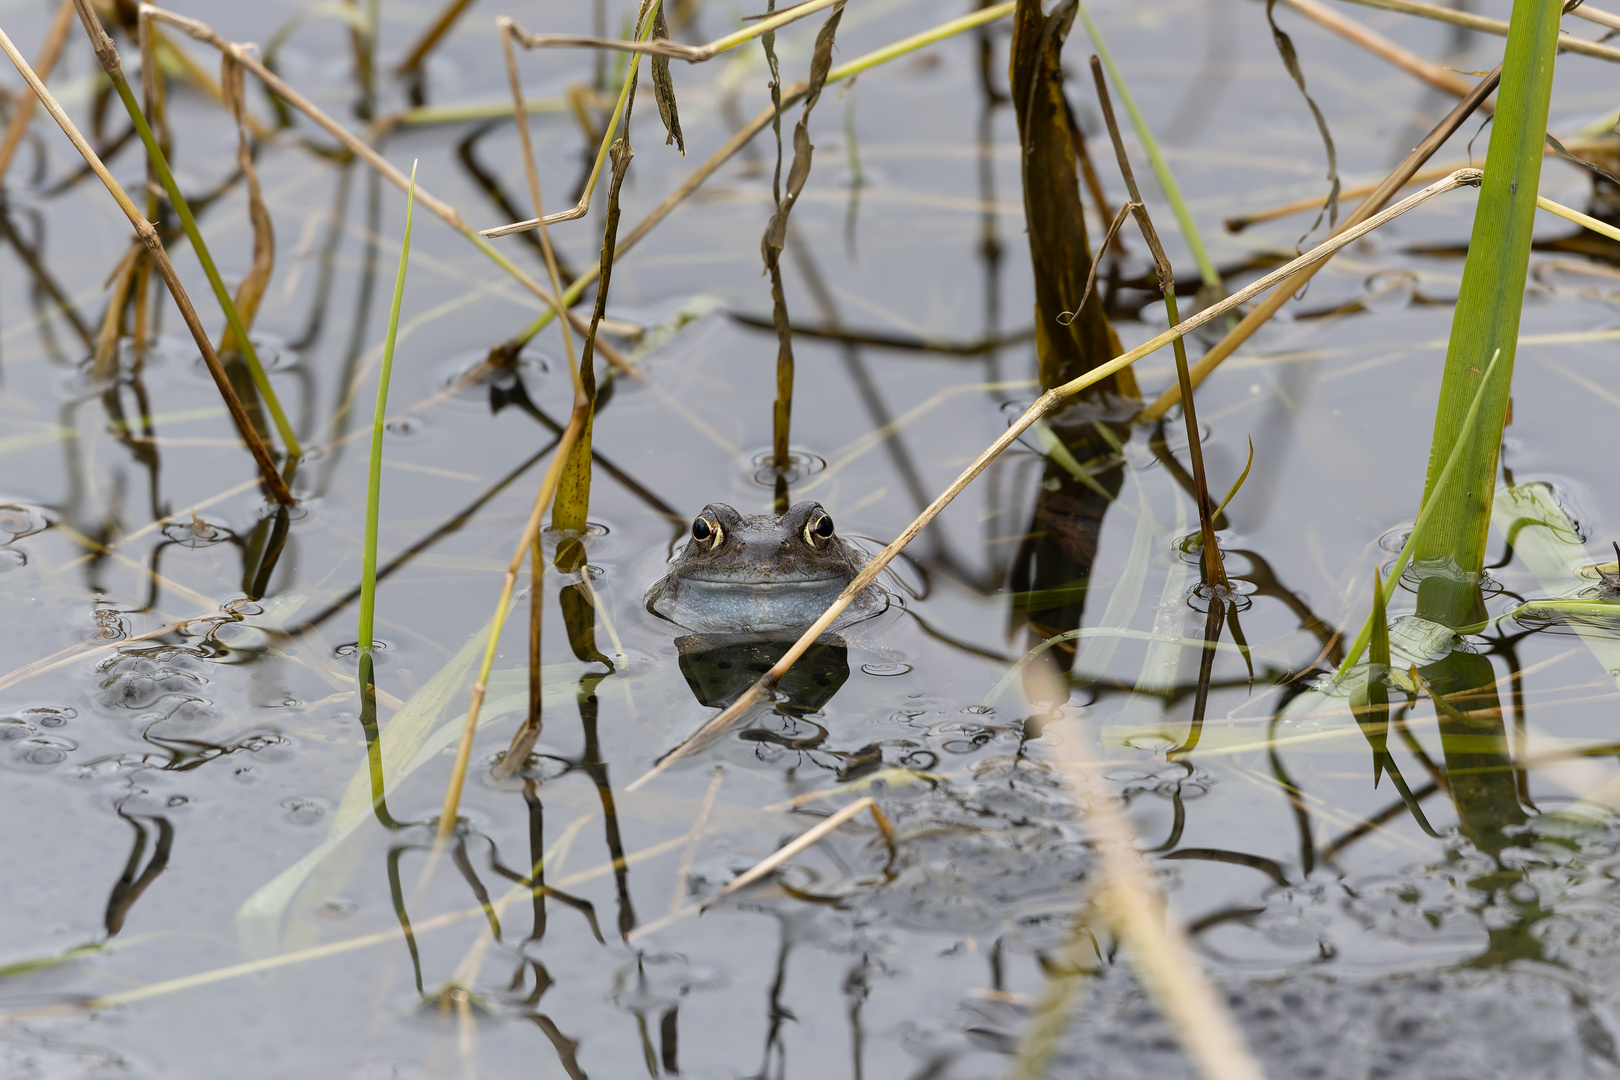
left=0, top=0, right=1620, bottom=1080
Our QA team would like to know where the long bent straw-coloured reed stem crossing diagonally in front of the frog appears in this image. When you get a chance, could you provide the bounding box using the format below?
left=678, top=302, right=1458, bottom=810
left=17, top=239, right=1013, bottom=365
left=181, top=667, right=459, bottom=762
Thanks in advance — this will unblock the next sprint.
left=625, top=168, right=1482, bottom=792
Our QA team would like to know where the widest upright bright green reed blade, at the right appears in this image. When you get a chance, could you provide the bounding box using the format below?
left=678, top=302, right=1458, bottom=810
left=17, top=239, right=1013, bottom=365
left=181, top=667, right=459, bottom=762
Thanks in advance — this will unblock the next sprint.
left=1414, top=0, right=1562, bottom=628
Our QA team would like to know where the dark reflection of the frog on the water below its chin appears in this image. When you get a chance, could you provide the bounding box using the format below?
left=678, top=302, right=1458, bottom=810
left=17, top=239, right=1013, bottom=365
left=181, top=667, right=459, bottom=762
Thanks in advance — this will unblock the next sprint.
left=676, top=633, right=849, bottom=750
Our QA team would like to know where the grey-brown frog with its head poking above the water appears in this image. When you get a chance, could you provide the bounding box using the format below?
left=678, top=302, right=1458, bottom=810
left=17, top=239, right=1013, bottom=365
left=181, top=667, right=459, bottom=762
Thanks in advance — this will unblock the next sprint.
left=646, top=502, right=888, bottom=635
